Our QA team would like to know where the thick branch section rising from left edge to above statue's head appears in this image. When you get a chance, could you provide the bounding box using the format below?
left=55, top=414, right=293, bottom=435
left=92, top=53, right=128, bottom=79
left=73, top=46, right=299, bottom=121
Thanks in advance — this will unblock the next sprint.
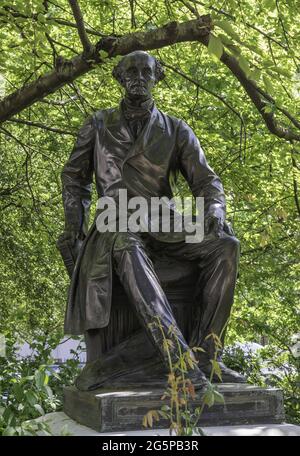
left=0, top=16, right=212, bottom=122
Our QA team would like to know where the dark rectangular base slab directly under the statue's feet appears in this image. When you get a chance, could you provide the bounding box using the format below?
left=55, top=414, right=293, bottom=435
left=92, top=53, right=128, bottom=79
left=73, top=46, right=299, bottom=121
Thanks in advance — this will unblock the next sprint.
left=64, top=383, right=284, bottom=432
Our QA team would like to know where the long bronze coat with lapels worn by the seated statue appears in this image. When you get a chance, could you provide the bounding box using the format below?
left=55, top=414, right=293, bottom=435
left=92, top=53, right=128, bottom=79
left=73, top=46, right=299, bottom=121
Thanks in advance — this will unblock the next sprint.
left=62, top=106, right=225, bottom=334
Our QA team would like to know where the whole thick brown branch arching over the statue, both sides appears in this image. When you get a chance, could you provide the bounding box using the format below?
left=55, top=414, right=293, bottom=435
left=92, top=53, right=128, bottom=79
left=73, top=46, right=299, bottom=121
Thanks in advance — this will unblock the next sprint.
left=0, top=13, right=300, bottom=141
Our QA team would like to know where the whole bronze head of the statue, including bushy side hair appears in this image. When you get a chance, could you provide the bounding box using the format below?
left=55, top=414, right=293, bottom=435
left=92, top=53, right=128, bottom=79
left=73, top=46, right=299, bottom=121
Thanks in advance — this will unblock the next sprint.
left=112, top=51, right=165, bottom=98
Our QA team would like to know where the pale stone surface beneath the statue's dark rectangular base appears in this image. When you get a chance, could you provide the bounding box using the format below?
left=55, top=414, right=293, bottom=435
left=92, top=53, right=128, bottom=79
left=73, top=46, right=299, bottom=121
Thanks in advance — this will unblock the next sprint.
left=34, top=412, right=300, bottom=436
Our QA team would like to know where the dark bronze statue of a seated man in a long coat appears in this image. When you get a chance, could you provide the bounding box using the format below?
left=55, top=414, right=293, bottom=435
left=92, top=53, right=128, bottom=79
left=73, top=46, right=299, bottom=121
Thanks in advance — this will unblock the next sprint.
left=60, top=51, right=245, bottom=389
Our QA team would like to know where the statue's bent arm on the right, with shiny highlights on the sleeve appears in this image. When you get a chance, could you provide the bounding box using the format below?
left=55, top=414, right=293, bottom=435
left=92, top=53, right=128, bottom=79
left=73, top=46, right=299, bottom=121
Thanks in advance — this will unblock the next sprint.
left=178, top=121, right=226, bottom=233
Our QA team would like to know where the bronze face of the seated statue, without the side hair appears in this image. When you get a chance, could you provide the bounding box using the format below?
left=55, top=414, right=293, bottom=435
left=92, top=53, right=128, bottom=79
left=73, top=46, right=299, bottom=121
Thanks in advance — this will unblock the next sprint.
left=122, top=52, right=156, bottom=98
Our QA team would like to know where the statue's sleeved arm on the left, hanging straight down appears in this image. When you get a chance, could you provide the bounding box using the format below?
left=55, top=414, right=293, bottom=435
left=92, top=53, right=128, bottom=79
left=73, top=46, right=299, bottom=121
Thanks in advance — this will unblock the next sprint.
left=61, top=116, right=95, bottom=240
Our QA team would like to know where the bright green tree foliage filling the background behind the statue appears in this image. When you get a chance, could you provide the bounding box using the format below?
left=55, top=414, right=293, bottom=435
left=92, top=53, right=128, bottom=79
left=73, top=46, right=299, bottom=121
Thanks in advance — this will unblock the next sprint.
left=0, top=0, right=300, bottom=426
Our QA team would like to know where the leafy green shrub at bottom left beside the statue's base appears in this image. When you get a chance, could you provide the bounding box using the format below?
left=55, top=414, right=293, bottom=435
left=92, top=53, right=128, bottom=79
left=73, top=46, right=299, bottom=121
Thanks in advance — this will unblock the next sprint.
left=0, top=334, right=79, bottom=435
